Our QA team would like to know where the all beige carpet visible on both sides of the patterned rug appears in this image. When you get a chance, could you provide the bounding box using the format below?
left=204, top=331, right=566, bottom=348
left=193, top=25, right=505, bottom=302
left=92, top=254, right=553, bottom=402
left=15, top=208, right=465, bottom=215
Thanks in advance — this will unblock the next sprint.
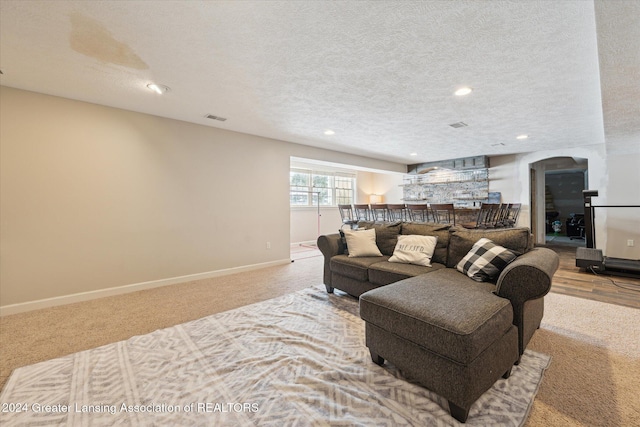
left=0, top=257, right=640, bottom=427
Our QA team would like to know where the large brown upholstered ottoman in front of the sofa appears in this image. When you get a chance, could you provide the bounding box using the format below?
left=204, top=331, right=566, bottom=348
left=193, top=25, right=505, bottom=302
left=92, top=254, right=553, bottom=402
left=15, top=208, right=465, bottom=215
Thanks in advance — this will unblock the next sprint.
left=360, top=269, right=519, bottom=422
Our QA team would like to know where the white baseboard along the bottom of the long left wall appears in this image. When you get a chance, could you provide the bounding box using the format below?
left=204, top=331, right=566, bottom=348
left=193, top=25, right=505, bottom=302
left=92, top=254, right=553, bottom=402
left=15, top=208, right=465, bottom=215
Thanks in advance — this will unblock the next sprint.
left=0, top=258, right=291, bottom=317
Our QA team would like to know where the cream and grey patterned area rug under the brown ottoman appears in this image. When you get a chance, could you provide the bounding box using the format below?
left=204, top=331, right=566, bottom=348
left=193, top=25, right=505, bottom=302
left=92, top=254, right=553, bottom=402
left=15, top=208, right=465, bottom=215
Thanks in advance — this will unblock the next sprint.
left=0, top=287, right=550, bottom=426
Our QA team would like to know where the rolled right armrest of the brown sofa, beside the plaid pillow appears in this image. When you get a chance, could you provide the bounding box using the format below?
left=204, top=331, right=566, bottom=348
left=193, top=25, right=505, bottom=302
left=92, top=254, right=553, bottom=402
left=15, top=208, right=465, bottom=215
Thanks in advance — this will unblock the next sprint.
left=496, top=248, right=560, bottom=306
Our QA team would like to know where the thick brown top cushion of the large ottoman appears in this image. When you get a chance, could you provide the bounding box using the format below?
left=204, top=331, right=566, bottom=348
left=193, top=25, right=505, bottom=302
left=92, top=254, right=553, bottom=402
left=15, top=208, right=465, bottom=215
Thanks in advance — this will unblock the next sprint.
left=360, top=268, right=513, bottom=364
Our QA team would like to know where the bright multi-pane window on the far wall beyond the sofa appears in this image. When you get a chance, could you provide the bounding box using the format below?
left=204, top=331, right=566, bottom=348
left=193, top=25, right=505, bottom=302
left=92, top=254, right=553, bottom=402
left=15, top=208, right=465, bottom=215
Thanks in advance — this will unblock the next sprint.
left=289, top=169, right=356, bottom=206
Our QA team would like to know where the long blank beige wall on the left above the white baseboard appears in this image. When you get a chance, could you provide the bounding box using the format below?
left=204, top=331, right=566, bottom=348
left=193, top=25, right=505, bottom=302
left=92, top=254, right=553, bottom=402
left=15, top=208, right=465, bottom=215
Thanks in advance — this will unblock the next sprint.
left=0, top=87, right=403, bottom=312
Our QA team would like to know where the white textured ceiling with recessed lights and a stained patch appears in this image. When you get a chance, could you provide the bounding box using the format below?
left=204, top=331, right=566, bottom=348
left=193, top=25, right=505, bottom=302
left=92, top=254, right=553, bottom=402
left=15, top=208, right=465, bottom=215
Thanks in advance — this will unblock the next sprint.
left=0, top=0, right=640, bottom=163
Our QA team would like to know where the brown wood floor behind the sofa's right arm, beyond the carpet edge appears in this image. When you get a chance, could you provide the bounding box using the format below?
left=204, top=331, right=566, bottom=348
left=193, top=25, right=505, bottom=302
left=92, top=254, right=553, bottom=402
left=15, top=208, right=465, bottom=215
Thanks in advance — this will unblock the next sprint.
left=545, top=245, right=640, bottom=308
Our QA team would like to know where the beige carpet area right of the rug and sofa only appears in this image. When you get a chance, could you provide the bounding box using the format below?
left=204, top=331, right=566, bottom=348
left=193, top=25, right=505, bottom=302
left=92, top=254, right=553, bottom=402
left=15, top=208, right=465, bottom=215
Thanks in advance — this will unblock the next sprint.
left=527, top=293, right=640, bottom=427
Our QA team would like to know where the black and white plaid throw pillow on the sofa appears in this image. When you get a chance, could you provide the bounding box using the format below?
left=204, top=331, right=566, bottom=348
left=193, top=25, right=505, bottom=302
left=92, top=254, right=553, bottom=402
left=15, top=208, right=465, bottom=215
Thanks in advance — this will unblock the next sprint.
left=456, top=237, right=516, bottom=282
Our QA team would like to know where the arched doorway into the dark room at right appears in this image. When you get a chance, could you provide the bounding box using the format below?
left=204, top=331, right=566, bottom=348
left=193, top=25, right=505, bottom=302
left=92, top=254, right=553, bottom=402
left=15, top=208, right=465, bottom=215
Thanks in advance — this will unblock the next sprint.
left=530, top=157, right=589, bottom=247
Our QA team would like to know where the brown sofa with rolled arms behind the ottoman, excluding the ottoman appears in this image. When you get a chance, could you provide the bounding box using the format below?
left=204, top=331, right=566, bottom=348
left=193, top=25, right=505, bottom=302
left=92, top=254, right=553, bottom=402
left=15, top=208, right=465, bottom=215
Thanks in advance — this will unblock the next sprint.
left=318, top=221, right=559, bottom=354
